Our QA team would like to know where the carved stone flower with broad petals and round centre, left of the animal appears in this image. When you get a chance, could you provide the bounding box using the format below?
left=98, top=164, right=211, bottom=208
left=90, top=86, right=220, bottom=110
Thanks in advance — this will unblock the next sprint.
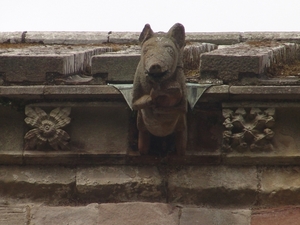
left=24, top=106, right=71, bottom=150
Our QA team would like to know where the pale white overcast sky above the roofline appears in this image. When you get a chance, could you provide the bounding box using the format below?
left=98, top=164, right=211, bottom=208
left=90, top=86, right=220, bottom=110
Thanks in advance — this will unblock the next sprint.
left=0, top=0, right=300, bottom=32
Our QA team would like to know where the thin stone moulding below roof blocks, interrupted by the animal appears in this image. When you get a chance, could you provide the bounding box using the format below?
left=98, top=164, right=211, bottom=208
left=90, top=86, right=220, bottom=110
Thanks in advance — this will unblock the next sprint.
left=0, top=85, right=300, bottom=101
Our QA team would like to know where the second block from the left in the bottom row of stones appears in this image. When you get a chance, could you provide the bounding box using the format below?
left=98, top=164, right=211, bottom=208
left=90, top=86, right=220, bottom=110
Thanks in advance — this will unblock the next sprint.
left=30, top=203, right=98, bottom=225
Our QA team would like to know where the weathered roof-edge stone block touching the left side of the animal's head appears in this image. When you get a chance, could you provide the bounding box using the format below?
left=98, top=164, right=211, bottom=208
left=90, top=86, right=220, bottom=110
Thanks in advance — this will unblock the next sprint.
left=92, top=54, right=140, bottom=82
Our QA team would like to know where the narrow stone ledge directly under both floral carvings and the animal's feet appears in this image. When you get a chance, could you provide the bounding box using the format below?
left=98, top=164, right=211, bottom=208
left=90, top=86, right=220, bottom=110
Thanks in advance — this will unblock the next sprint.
left=9, top=151, right=300, bottom=166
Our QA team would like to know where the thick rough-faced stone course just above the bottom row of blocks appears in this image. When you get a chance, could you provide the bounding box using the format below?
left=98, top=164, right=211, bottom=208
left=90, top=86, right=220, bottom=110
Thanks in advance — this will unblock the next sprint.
left=0, top=165, right=300, bottom=208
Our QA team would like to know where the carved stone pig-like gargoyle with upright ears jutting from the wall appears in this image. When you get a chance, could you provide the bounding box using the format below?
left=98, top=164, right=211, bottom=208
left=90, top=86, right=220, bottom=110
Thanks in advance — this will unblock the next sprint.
left=132, top=23, right=187, bottom=155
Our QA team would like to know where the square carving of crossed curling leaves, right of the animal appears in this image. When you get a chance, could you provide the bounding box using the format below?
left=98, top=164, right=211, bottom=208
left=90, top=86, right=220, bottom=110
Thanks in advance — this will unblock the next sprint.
left=223, top=108, right=275, bottom=152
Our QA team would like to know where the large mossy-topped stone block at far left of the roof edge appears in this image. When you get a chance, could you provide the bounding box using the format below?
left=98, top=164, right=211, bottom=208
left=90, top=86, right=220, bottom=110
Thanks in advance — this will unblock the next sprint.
left=0, top=44, right=112, bottom=83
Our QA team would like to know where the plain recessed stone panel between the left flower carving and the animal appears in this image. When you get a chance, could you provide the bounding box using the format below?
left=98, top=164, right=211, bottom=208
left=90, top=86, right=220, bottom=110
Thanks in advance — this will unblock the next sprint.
left=69, top=102, right=130, bottom=154
